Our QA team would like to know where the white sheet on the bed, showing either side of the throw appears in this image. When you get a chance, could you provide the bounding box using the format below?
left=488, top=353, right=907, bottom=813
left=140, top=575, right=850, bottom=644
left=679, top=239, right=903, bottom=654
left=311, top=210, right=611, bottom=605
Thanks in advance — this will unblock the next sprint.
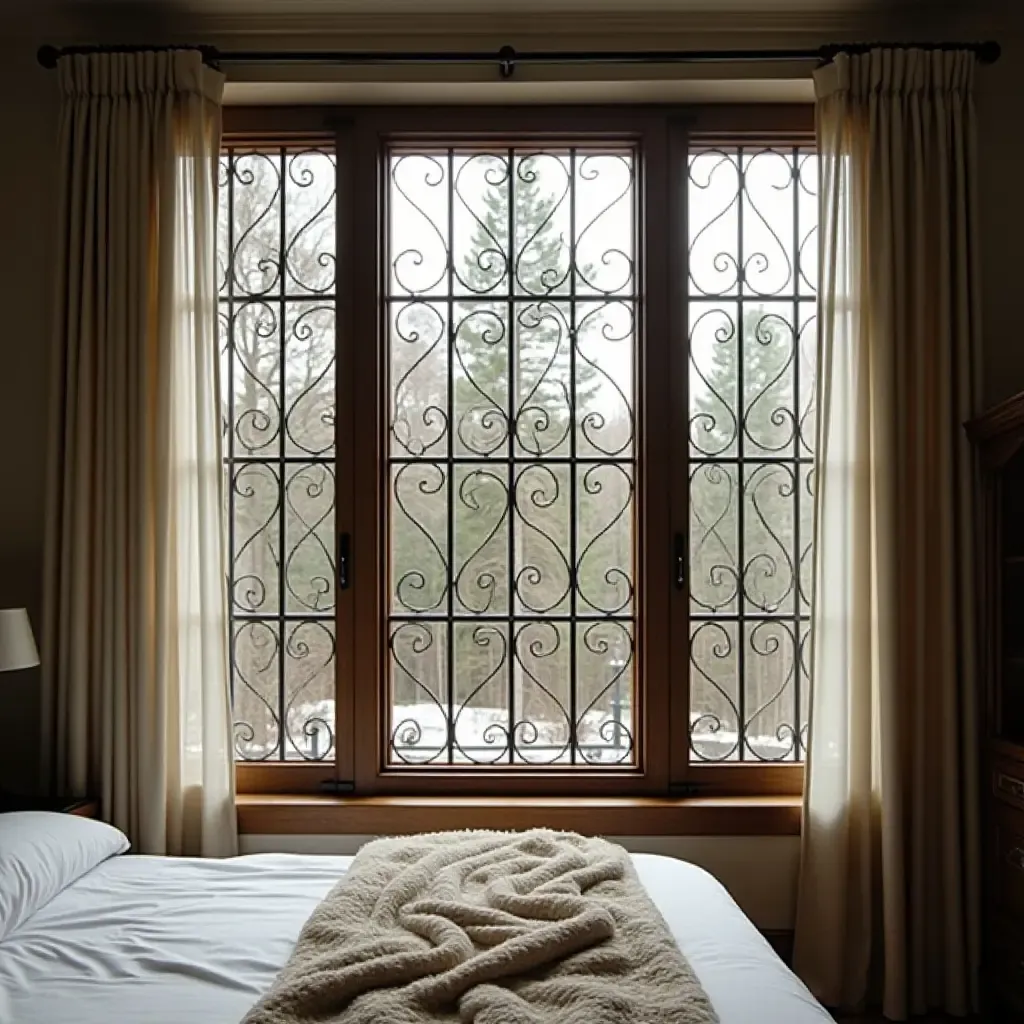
left=0, top=854, right=833, bottom=1024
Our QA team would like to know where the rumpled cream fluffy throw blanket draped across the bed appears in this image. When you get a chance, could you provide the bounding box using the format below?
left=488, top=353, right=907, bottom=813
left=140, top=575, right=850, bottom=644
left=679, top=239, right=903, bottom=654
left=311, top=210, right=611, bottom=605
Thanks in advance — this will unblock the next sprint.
left=243, top=829, right=717, bottom=1024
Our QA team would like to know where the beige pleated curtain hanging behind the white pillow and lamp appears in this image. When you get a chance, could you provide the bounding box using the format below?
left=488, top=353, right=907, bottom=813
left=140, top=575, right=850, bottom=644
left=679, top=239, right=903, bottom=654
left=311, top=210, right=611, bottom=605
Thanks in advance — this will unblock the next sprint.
left=43, top=50, right=237, bottom=856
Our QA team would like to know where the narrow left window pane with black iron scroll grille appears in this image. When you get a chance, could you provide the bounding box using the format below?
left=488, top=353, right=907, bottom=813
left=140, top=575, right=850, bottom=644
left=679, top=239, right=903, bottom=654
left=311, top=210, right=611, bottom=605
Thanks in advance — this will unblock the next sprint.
left=218, top=146, right=337, bottom=762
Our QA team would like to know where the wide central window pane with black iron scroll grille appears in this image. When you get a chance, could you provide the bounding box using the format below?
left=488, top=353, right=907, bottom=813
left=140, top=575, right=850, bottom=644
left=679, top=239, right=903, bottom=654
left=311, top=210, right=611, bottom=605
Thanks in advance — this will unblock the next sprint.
left=385, top=145, right=640, bottom=767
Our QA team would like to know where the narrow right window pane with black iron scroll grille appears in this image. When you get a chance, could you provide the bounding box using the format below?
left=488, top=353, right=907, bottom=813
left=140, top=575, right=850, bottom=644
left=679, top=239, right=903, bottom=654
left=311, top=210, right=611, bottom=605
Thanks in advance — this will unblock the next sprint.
left=687, top=146, right=817, bottom=761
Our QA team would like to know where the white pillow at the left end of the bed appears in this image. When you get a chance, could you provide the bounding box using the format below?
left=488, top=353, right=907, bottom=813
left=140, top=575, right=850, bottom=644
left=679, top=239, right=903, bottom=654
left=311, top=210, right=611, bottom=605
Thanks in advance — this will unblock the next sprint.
left=0, top=811, right=130, bottom=941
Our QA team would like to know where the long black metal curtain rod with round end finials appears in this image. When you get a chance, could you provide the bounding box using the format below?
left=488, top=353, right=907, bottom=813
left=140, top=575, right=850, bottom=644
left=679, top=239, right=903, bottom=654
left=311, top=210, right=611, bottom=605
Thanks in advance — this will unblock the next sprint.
left=37, top=41, right=1000, bottom=78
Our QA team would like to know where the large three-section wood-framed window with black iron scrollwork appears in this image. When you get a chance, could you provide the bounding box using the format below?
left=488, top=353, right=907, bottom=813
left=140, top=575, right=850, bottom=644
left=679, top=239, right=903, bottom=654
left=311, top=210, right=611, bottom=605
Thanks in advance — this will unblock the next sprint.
left=220, top=108, right=817, bottom=794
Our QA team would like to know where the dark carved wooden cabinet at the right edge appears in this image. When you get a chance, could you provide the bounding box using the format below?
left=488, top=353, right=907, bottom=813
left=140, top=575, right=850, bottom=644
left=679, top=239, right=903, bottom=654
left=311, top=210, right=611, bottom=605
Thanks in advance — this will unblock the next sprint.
left=967, top=393, right=1024, bottom=1022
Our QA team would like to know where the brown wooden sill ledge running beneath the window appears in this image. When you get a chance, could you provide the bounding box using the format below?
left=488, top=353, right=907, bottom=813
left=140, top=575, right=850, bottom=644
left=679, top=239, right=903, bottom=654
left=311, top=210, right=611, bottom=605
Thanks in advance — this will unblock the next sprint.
left=236, top=794, right=802, bottom=836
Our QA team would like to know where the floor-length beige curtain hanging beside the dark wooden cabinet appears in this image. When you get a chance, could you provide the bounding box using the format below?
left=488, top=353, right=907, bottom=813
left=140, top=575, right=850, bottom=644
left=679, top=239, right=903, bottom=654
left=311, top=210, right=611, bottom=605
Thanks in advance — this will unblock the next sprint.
left=795, top=50, right=980, bottom=1020
